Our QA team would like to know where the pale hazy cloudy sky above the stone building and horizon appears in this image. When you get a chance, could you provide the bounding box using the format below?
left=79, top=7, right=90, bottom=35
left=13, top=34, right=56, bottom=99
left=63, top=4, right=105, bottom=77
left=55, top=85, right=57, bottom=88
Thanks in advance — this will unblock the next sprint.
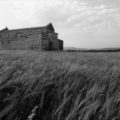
left=0, top=0, right=120, bottom=48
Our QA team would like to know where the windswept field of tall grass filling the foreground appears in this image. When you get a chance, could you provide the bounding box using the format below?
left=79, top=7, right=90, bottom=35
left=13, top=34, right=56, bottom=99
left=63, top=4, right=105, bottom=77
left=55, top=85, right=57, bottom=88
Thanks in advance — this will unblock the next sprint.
left=0, top=51, right=120, bottom=120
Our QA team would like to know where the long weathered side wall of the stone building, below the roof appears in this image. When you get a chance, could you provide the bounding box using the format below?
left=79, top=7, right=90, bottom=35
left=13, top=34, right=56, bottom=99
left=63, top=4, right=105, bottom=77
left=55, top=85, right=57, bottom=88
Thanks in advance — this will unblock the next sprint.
left=1, top=29, right=42, bottom=49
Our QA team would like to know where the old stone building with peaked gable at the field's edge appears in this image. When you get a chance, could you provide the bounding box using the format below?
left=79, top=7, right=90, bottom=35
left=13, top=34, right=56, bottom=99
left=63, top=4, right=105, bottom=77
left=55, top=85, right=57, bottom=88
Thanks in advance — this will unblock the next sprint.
left=0, top=23, right=63, bottom=50
